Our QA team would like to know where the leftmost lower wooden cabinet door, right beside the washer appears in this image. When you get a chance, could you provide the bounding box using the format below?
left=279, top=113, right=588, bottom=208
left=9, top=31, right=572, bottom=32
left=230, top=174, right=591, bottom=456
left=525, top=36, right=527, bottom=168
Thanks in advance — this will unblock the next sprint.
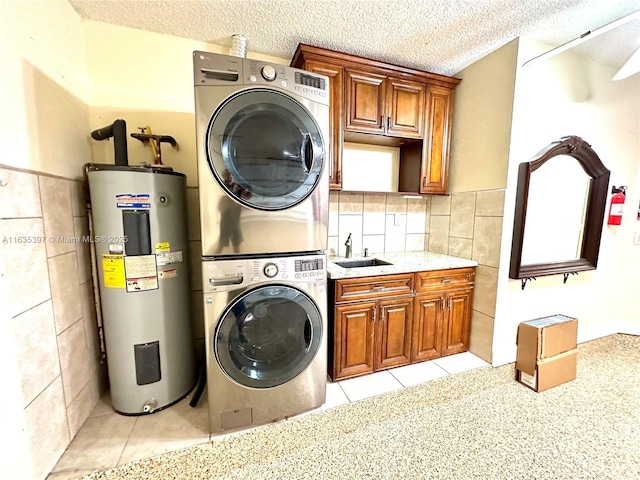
left=333, top=302, right=376, bottom=380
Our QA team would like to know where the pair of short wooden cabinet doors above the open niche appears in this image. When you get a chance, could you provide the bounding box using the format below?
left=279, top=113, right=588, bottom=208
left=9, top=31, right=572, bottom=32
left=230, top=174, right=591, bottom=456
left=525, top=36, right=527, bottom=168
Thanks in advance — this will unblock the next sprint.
left=345, top=69, right=426, bottom=139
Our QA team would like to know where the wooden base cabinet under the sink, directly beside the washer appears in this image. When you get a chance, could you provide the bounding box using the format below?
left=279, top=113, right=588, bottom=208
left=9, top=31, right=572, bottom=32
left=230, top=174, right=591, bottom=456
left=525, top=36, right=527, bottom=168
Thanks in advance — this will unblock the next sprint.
left=328, top=274, right=414, bottom=380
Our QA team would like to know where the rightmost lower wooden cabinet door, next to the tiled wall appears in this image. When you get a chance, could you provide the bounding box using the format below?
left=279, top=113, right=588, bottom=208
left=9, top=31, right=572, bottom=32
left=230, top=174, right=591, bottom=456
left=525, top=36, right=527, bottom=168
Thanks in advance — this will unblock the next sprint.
left=442, top=289, right=473, bottom=355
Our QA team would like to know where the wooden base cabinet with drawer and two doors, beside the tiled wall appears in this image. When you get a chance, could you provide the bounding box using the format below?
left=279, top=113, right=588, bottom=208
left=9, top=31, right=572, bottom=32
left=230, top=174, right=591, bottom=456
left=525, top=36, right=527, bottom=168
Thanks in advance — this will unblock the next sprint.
left=411, top=268, right=475, bottom=362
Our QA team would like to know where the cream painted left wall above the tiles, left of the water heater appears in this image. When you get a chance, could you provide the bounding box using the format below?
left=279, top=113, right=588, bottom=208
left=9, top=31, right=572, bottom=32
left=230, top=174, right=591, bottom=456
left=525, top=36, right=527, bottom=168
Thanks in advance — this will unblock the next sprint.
left=0, top=0, right=90, bottom=178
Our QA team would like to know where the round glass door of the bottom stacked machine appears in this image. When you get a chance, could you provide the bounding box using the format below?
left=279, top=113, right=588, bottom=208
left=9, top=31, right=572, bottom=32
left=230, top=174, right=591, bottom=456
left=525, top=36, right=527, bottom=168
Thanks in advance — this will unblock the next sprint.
left=212, top=285, right=323, bottom=388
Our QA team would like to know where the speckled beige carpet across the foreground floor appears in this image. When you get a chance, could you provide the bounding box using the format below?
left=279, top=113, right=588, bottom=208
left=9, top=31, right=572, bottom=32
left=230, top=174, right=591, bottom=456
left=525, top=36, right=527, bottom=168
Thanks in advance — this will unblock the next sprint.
left=85, top=335, right=640, bottom=480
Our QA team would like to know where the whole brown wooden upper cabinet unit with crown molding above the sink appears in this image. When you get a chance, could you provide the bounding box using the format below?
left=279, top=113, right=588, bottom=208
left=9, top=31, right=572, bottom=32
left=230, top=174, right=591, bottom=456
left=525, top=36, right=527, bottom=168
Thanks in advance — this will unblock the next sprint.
left=291, top=44, right=460, bottom=194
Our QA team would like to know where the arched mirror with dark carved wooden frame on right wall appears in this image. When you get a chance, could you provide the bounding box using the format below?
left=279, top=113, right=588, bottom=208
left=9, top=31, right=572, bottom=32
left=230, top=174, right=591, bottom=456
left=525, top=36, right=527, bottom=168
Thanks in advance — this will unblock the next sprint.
left=509, top=136, right=610, bottom=282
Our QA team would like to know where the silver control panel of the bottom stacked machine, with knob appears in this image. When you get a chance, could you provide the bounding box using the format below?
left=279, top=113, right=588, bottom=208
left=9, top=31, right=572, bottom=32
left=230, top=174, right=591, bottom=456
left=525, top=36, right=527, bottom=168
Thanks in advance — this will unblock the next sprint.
left=202, top=254, right=327, bottom=292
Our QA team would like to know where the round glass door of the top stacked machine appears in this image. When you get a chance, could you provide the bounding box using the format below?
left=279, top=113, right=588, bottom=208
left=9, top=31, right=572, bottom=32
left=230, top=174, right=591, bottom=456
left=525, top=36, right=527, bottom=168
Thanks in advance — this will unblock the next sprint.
left=205, top=88, right=326, bottom=210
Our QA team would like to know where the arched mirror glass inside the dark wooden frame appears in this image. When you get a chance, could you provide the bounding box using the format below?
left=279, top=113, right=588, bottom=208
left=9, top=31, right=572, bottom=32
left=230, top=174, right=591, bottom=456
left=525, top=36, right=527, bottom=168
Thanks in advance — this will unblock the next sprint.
left=521, top=155, right=591, bottom=265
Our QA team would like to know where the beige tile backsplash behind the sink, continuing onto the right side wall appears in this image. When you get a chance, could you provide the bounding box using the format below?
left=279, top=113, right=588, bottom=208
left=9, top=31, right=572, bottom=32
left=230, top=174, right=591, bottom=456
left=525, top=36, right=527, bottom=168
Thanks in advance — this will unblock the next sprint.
left=328, top=190, right=504, bottom=362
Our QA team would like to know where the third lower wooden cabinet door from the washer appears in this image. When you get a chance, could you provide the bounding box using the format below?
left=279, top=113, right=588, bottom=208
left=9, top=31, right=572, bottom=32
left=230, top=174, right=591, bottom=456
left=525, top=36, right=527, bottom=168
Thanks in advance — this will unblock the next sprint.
left=411, top=293, right=445, bottom=362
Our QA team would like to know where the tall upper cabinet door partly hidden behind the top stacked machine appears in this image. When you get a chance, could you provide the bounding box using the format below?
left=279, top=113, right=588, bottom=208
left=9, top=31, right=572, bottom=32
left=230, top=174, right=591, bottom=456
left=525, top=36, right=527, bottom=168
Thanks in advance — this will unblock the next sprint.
left=303, top=60, right=344, bottom=190
